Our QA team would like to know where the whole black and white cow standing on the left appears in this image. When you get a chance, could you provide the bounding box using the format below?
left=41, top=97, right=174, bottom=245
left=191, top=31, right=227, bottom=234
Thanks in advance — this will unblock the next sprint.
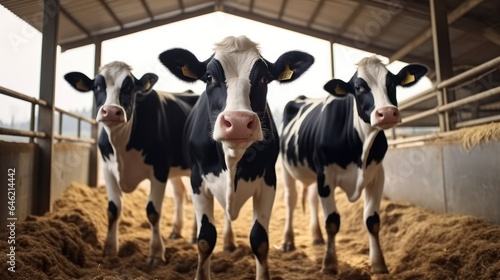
left=64, top=62, right=197, bottom=266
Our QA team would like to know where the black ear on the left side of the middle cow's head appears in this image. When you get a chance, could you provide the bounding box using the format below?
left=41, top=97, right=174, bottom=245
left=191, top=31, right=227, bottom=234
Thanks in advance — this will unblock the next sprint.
left=159, top=48, right=207, bottom=82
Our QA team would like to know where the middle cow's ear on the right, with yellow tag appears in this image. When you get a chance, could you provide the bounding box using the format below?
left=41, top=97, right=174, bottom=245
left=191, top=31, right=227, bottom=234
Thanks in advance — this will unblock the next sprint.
left=268, top=51, right=314, bottom=83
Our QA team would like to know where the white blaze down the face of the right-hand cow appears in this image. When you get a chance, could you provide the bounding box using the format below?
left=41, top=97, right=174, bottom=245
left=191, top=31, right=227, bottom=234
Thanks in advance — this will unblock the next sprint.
left=358, top=56, right=396, bottom=124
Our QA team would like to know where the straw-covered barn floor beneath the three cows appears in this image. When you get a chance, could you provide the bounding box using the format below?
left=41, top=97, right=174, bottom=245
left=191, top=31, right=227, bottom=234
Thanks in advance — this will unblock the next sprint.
left=0, top=163, right=500, bottom=280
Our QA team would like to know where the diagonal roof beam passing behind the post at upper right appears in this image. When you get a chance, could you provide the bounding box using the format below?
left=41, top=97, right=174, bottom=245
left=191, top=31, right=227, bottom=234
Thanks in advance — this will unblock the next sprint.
left=389, top=0, right=484, bottom=62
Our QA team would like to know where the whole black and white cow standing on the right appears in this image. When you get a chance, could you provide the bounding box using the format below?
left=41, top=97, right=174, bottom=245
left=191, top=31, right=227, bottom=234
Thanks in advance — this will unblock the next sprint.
left=280, top=56, right=427, bottom=273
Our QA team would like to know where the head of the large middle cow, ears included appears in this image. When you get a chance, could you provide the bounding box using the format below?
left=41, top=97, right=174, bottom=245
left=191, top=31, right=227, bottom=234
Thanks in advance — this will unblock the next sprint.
left=160, top=36, right=314, bottom=149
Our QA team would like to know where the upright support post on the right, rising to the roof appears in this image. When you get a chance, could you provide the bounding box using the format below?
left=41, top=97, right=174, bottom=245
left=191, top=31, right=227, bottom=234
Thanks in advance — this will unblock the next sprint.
left=429, top=0, right=456, bottom=132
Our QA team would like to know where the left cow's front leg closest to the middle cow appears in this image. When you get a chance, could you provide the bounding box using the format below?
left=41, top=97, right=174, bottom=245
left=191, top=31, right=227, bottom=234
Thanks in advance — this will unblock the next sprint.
left=146, top=178, right=166, bottom=266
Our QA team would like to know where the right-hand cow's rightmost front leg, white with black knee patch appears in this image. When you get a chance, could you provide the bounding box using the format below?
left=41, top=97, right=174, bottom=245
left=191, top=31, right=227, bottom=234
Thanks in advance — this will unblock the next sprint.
left=363, top=166, right=389, bottom=273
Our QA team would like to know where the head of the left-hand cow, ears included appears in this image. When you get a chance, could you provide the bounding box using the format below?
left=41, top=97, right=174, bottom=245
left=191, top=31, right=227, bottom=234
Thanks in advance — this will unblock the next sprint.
left=64, top=61, right=158, bottom=127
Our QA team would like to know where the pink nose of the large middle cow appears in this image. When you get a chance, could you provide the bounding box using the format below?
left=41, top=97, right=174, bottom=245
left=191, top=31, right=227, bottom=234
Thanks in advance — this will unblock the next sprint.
left=214, top=111, right=260, bottom=141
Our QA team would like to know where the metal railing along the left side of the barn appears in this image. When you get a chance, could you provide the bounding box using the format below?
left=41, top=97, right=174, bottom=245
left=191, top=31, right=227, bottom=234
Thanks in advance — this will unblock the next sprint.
left=0, top=86, right=97, bottom=144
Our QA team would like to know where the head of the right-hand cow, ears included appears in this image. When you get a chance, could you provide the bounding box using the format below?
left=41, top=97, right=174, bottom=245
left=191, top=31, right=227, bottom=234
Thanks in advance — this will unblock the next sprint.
left=324, top=56, right=428, bottom=129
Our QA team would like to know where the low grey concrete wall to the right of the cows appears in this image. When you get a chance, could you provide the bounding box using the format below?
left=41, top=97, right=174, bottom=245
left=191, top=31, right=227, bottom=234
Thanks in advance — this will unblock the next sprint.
left=384, top=142, right=500, bottom=224
